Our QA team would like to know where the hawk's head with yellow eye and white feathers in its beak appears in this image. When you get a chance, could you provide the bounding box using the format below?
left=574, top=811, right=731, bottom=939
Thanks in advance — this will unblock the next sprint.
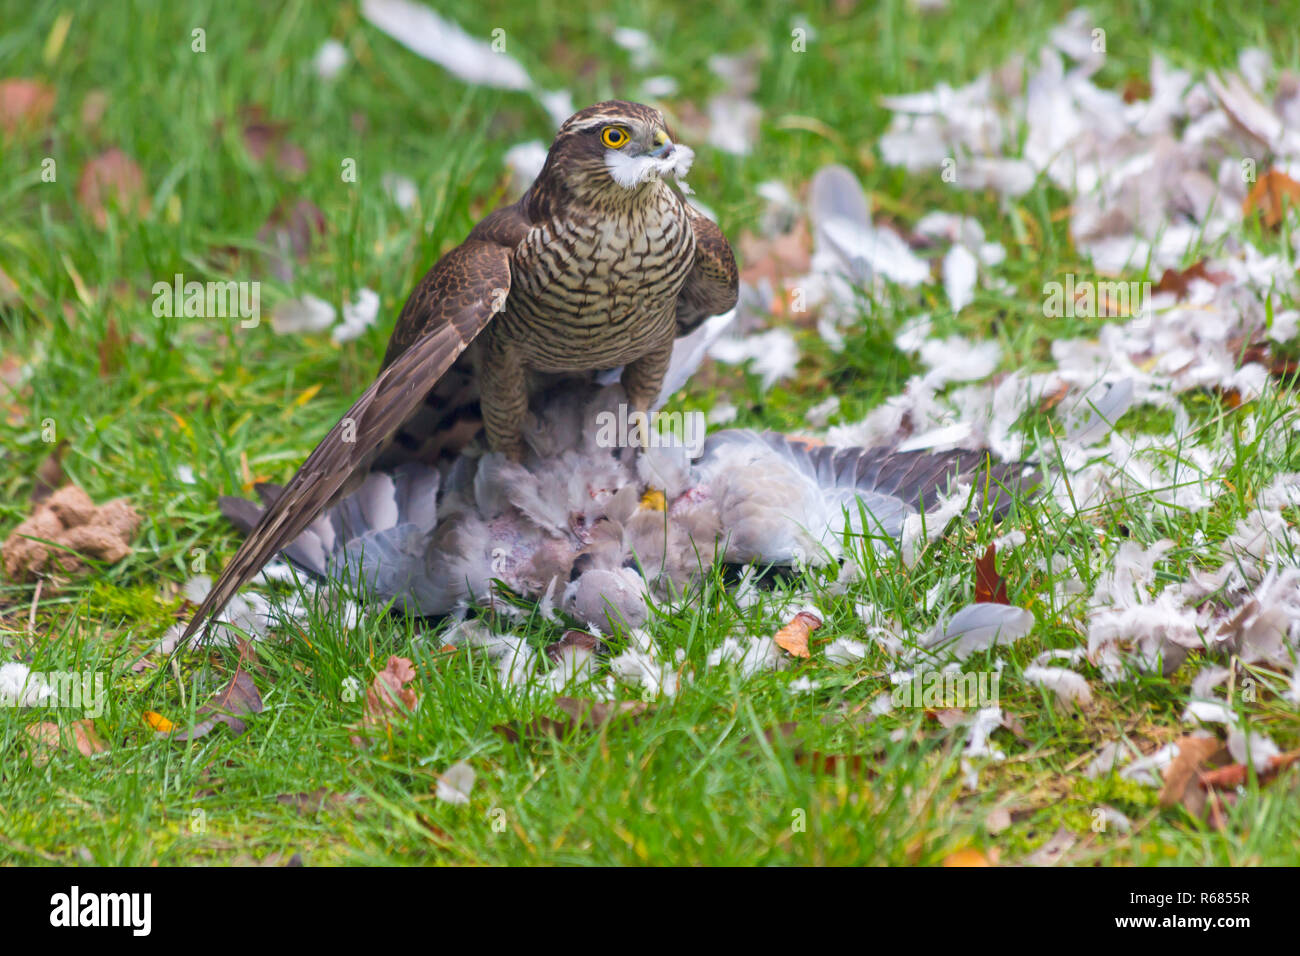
left=538, top=100, right=696, bottom=199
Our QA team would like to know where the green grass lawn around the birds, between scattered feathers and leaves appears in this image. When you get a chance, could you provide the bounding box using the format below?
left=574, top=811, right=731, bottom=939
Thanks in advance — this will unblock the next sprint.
left=0, top=0, right=1300, bottom=865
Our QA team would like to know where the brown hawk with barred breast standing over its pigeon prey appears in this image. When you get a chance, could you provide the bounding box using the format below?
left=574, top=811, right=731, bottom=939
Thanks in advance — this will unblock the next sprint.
left=181, top=100, right=738, bottom=645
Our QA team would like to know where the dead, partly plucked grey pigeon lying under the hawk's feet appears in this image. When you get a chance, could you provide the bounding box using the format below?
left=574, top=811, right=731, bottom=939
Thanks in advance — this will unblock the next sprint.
left=221, top=385, right=1030, bottom=630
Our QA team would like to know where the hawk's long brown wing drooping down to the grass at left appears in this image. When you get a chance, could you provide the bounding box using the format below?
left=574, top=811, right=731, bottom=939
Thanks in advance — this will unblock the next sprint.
left=177, top=234, right=512, bottom=646
